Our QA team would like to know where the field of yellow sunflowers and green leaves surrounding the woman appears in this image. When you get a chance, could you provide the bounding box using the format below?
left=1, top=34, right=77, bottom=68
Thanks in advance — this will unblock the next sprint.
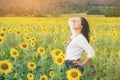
left=0, top=16, right=120, bottom=80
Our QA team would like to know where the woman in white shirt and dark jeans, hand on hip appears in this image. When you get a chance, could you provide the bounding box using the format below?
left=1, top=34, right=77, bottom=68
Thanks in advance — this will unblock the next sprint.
left=65, top=17, right=95, bottom=79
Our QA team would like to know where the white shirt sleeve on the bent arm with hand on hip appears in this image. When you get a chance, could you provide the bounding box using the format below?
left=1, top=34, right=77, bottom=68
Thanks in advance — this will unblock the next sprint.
left=79, top=37, right=95, bottom=58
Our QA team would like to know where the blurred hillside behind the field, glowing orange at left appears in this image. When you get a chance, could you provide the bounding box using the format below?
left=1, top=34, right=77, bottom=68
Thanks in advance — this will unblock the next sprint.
left=0, top=0, right=120, bottom=17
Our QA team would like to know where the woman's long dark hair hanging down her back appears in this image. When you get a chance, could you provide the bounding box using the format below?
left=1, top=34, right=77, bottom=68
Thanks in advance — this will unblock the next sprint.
left=80, top=17, right=90, bottom=42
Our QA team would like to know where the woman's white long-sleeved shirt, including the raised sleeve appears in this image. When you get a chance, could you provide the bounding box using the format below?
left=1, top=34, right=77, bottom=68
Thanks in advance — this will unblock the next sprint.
left=65, top=21, right=95, bottom=60
